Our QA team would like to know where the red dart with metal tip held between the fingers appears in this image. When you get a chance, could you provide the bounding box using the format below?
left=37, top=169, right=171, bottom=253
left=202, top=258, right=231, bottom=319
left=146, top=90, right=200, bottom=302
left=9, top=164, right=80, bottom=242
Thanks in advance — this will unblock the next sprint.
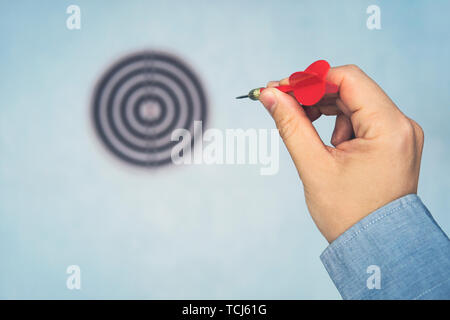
left=237, top=60, right=339, bottom=106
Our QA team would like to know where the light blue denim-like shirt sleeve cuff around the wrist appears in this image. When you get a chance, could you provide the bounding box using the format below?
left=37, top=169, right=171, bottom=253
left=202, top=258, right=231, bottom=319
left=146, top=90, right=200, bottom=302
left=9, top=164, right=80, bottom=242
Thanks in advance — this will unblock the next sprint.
left=320, top=194, right=450, bottom=299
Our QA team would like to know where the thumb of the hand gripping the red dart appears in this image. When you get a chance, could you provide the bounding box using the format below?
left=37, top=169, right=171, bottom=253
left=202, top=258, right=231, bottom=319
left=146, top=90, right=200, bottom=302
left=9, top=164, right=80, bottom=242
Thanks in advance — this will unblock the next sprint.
left=259, top=88, right=330, bottom=177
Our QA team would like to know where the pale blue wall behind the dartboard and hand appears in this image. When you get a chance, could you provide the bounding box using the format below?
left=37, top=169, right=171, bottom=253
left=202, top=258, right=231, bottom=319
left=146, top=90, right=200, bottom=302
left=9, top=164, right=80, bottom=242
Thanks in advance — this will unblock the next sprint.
left=0, top=0, right=450, bottom=299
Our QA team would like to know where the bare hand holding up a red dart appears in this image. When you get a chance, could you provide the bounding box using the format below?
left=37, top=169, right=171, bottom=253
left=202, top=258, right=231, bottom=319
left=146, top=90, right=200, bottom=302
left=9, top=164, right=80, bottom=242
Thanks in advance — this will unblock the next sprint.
left=260, top=65, right=424, bottom=242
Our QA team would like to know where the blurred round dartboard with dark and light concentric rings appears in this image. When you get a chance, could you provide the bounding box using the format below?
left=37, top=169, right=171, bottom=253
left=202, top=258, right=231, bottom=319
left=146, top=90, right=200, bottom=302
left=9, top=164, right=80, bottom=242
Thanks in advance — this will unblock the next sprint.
left=92, top=51, right=207, bottom=166
